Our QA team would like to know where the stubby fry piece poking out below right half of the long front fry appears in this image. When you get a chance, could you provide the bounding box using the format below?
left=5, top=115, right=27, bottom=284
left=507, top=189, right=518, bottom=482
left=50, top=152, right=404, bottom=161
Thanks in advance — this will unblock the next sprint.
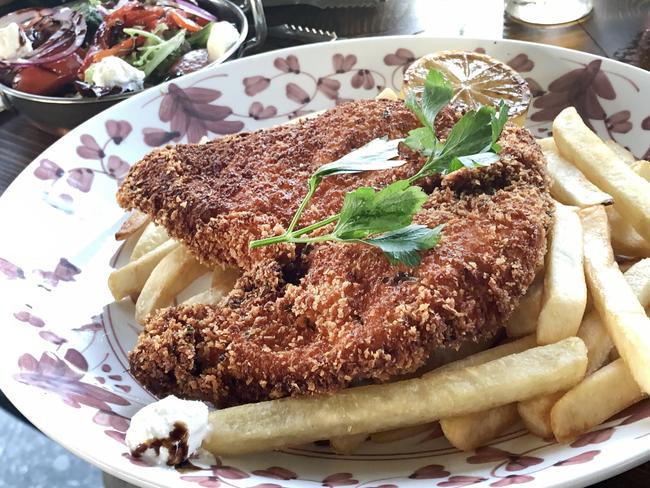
left=440, top=403, right=519, bottom=451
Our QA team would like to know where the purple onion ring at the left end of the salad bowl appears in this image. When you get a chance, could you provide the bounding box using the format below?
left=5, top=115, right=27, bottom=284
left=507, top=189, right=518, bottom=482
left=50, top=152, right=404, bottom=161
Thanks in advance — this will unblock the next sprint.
left=0, top=8, right=86, bottom=67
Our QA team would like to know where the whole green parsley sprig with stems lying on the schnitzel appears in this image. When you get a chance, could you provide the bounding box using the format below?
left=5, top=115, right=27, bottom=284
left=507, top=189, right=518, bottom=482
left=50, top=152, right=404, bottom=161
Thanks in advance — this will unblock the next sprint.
left=250, top=69, right=508, bottom=266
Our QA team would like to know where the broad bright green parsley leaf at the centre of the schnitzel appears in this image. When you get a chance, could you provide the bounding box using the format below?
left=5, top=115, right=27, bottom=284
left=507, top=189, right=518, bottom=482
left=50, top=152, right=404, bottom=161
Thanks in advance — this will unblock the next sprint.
left=332, top=180, right=427, bottom=239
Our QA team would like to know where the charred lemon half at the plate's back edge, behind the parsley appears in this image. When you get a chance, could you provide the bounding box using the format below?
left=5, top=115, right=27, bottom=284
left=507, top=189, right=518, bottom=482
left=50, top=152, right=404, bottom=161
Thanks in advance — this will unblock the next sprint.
left=402, top=51, right=531, bottom=125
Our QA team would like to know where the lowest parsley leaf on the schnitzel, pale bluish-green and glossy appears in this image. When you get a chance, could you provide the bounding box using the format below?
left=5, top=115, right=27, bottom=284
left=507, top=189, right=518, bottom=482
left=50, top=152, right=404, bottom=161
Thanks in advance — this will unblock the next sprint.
left=362, top=224, right=444, bottom=266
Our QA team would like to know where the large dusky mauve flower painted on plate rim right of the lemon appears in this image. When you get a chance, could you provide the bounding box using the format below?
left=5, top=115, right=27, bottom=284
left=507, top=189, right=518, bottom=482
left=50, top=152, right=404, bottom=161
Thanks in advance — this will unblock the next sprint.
left=530, top=59, right=616, bottom=129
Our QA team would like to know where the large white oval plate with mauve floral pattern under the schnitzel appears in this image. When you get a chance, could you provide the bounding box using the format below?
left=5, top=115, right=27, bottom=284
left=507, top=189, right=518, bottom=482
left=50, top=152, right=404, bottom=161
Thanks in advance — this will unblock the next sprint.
left=0, top=37, right=650, bottom=488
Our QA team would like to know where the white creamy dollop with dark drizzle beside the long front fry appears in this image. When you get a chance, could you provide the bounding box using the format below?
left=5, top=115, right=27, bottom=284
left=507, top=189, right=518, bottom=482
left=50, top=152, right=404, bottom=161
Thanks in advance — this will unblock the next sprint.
left=126, top=395, right=209, bottom=466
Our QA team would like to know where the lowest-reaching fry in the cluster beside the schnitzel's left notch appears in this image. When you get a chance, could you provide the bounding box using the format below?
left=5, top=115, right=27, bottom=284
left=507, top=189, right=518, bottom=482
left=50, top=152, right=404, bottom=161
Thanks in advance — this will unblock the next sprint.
left=135, top=246, right=208, bottom=323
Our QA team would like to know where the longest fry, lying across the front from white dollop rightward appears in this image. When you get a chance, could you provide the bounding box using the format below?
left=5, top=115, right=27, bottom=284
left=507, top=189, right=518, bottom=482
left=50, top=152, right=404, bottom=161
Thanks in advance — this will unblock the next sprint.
left=203, top=337, right=587, bottom=455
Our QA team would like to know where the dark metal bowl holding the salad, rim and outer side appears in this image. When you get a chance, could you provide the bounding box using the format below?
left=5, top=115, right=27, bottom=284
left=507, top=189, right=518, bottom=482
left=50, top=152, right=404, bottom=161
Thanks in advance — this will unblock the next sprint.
left=0, top=0, right=266, bottom=135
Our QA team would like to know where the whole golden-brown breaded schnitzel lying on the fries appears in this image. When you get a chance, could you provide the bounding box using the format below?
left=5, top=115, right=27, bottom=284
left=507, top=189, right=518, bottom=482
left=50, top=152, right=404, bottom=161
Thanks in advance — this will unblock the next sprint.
left=118, top=100, right=552, bottom=406
